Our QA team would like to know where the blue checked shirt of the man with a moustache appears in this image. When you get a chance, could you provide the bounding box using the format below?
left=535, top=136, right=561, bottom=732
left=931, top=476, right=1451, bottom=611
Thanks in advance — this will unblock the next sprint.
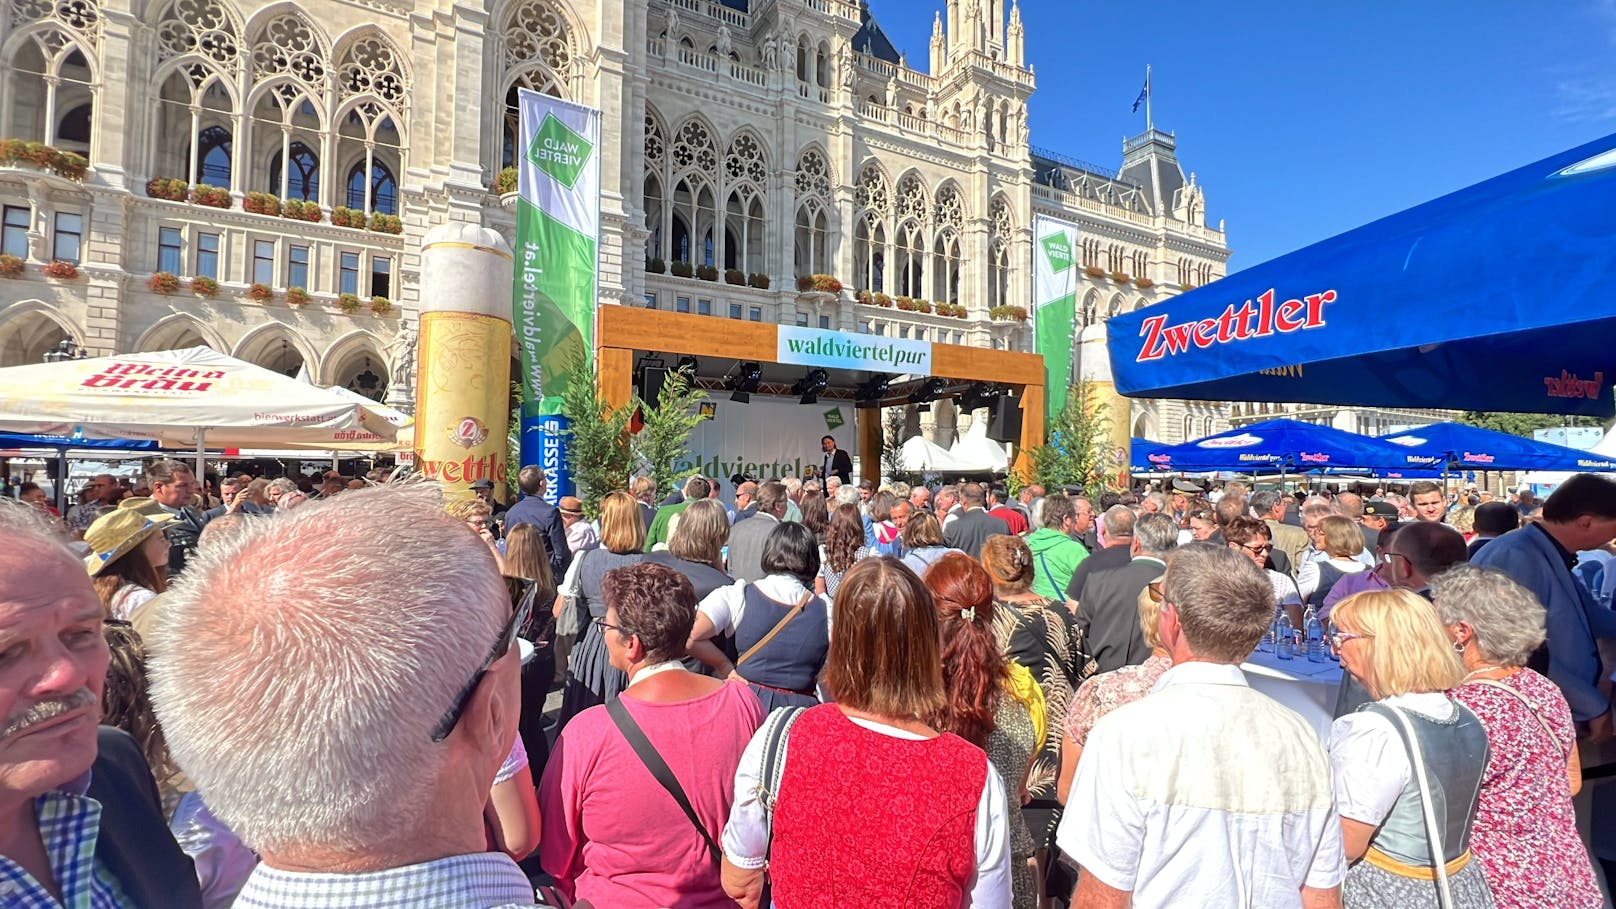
left=0, top=778, right=137, bottom=909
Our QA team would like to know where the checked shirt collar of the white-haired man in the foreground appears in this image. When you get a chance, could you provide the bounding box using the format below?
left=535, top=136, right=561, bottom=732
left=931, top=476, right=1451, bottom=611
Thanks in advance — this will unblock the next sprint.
left=234, top=852, right=538, bottom=909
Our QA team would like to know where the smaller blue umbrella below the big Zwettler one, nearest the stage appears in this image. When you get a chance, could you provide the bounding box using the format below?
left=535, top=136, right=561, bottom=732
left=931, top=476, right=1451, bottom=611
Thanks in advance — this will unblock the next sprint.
left=1133, top=419, right=1408, bottom=472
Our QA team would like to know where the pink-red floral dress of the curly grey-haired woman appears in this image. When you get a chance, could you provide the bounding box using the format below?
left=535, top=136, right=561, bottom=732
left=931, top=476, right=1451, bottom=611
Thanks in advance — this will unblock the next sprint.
left=1453, top=670, right=1603, bottom=909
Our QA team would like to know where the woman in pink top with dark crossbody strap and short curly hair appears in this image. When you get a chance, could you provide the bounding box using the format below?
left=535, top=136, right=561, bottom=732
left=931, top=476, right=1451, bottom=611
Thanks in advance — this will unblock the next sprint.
left=538, top=563, right=763, bottom=909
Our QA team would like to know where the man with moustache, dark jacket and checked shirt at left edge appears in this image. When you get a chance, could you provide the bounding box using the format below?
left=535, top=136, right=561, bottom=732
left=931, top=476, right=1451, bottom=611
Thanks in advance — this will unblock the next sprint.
left=0, top=494, right=202, bottom=909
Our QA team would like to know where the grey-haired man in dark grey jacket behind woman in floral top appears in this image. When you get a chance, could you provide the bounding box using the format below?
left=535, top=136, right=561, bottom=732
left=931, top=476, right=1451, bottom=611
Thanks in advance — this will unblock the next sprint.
left=1076, top=514, right=1178, bottom=673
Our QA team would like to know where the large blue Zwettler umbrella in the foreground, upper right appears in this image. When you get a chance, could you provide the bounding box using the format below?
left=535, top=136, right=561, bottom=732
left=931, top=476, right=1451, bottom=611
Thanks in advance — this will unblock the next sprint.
left=1107, top=136, right=1616, bottom=416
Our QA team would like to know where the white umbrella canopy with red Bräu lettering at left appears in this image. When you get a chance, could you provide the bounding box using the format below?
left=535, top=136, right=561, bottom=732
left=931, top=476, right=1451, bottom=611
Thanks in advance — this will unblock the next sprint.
left=0, top=348, right=399, bottom=448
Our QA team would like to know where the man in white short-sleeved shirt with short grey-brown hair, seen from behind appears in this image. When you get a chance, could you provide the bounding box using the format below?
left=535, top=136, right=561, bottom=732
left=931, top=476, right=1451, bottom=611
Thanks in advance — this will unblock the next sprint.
left=1055, top=543, right=1346, bottom=909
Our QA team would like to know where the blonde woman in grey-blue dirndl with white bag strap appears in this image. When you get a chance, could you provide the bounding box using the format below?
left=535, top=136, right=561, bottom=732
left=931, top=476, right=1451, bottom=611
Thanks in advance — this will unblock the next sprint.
left=1330, top=590, right=1493, bottom=909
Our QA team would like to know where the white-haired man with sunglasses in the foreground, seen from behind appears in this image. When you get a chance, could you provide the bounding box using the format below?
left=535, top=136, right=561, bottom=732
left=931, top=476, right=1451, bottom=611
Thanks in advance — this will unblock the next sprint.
left=150, top=484, right=533, bottom=909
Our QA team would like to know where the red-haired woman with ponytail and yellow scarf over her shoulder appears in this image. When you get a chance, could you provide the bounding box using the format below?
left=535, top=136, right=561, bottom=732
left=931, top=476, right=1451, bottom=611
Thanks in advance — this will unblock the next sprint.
left=924, top=553, right=1046, bottom=909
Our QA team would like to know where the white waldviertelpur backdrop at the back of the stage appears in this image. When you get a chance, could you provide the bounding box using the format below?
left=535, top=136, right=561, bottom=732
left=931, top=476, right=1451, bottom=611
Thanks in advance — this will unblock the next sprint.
left=674, top=395, right=858, bottom=488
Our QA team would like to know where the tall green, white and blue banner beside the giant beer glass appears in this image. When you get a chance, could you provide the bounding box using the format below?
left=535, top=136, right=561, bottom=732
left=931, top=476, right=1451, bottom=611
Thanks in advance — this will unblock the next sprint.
left=512, top=89, right=601, bottom=501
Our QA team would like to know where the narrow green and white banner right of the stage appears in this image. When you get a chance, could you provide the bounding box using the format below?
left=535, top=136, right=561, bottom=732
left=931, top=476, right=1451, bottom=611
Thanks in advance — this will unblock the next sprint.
left=1033, top=215, right=1083, bottom=421
